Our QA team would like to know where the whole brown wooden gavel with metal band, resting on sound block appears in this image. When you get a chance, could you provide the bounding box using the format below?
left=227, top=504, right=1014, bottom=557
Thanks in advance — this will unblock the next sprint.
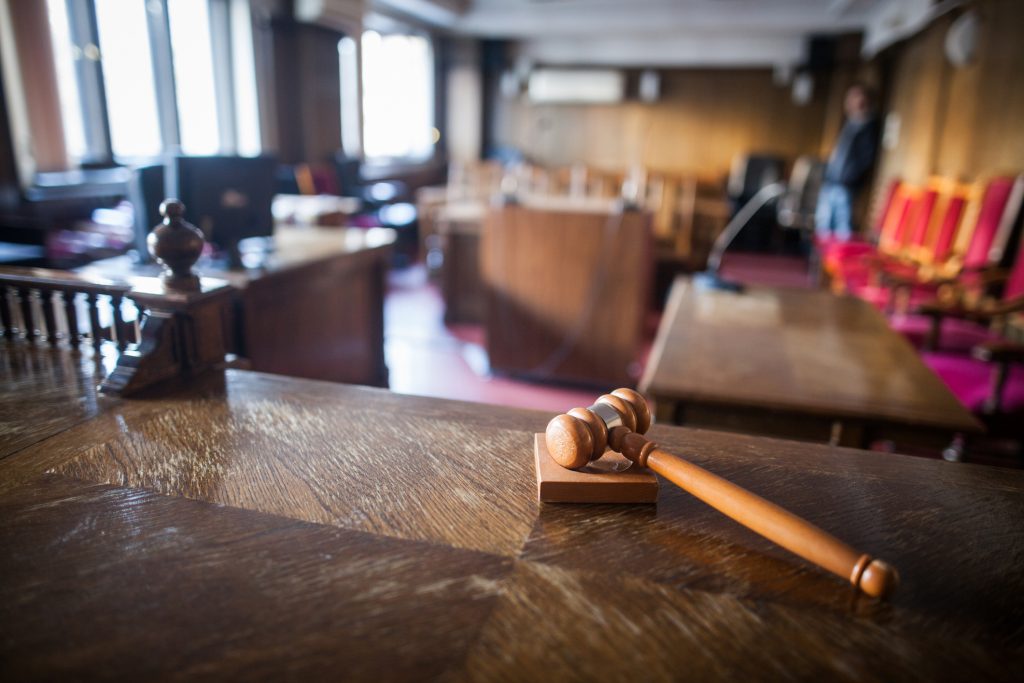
left=545, top=389, right=899, bottom=598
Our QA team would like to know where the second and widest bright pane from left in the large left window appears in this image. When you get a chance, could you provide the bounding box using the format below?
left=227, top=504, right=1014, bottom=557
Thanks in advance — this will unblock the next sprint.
left=95, top=0, right=162, bottom=158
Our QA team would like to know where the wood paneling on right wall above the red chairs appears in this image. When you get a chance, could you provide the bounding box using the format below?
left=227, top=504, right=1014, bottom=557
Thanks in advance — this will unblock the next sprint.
left=877, top=0, right=1024, bottom=196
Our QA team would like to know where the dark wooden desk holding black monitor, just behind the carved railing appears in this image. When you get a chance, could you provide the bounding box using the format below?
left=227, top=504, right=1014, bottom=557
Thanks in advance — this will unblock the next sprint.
left=81, top=225, right=395, bottom=386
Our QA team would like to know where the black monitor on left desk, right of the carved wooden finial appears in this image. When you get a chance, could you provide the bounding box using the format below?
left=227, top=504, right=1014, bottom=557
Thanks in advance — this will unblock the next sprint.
left=174, top=157, right=278, bottom=249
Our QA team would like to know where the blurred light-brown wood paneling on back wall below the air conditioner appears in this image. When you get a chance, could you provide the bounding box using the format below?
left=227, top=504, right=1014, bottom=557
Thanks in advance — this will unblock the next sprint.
left=499, top=69, right=825, bottom=178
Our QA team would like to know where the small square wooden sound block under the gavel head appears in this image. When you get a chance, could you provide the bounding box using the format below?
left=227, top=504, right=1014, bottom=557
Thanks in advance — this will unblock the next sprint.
left=534, top=434, right=657, bottom=503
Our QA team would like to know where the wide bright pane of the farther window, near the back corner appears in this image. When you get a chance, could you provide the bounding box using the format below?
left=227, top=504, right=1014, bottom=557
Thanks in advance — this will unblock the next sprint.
left=362, top=31, right=438, bottom=161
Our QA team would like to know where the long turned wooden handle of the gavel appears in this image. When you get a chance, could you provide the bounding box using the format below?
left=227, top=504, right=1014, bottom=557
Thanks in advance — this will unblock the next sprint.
left=611, top=432, right=899, bottom=598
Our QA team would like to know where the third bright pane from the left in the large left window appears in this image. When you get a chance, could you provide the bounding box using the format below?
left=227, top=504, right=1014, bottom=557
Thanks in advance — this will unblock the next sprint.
left=167, top=0, right=220, bottom=155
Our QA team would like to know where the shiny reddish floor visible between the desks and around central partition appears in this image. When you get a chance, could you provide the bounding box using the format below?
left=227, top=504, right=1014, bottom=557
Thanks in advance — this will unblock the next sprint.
left=384, top=254, right=808, bottom=412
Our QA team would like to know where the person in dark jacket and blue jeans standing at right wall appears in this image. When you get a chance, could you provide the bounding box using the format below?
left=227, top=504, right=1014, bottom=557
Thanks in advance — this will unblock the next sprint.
left=814, top=83, right=879, bottom=242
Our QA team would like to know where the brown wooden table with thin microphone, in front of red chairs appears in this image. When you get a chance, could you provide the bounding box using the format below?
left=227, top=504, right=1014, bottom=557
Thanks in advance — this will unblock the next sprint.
left=640, top=278, right=982, bottom=449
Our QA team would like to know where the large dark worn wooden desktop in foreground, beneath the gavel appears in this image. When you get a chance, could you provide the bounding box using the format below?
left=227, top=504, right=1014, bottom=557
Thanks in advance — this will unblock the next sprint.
left=0, top=362, right=1024, bottom=681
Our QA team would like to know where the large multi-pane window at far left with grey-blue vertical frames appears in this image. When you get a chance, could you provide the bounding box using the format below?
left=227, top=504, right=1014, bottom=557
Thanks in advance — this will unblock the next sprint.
left=47, top=0, right=260, bottom=165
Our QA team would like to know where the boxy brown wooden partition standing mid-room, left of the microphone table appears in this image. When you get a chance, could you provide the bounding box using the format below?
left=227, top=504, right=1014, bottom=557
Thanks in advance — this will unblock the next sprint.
left=480, top=201, right=651, bottom=386
